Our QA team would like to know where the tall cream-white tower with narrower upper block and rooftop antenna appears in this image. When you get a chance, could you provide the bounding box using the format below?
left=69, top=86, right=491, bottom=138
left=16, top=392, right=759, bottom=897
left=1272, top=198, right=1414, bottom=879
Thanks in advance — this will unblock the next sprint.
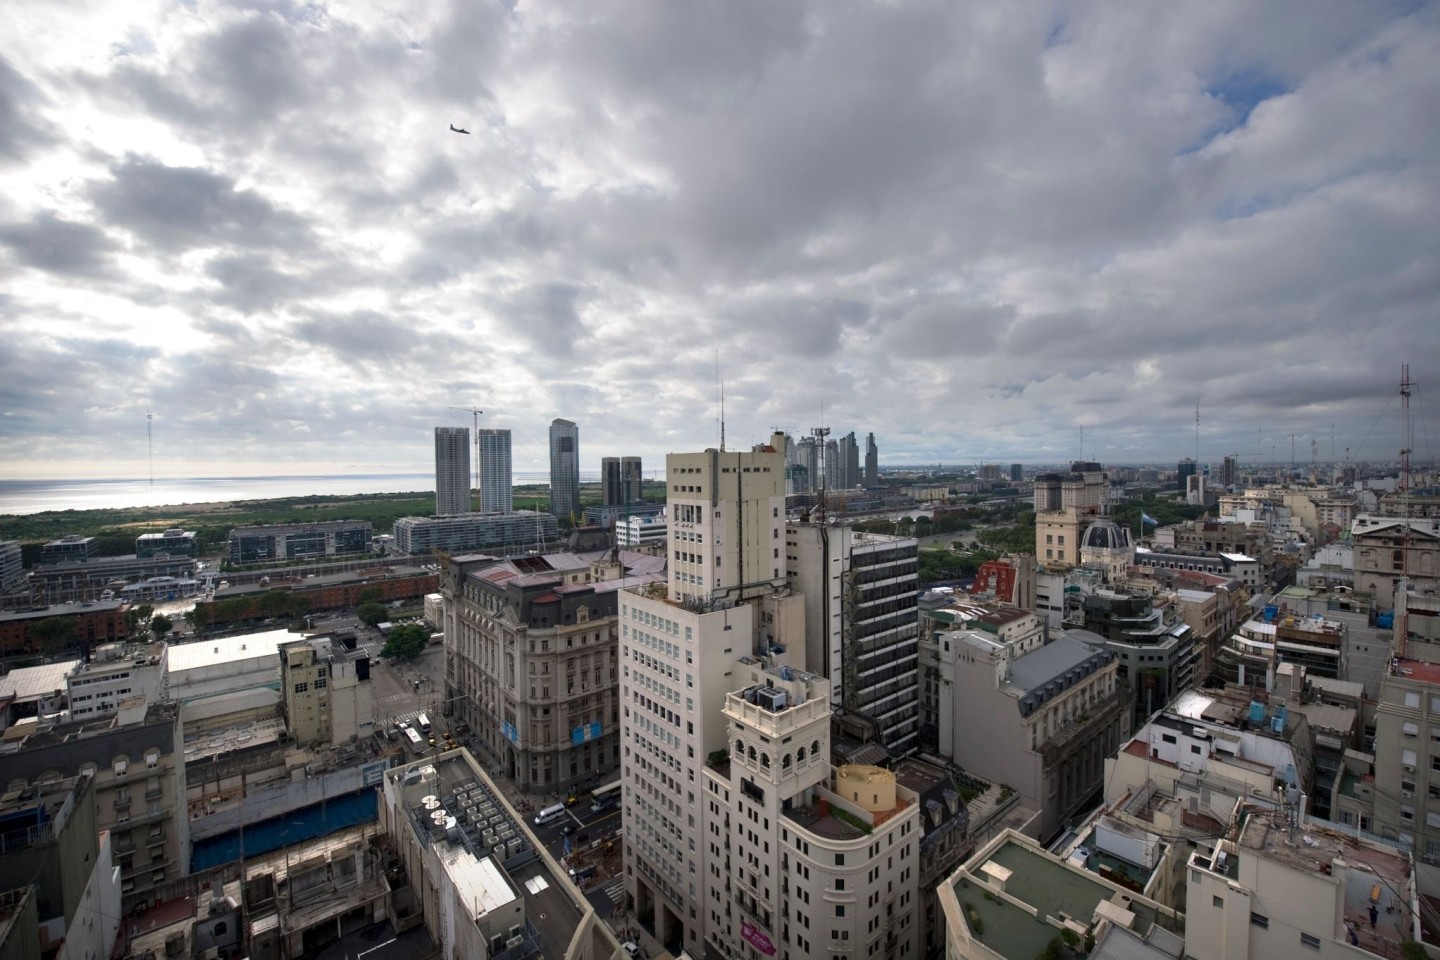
left=619, top=449, right=804, bottom=956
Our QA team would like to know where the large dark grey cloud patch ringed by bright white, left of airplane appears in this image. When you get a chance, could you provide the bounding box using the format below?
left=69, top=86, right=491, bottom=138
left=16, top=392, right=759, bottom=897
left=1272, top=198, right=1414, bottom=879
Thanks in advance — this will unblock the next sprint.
left=89, top=157, right=308, bottom=252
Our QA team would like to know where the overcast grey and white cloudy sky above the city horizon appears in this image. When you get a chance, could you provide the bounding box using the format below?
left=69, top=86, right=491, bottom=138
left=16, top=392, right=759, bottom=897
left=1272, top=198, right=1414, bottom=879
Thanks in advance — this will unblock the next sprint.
left=0, top=0, right=1440, bottom=478
